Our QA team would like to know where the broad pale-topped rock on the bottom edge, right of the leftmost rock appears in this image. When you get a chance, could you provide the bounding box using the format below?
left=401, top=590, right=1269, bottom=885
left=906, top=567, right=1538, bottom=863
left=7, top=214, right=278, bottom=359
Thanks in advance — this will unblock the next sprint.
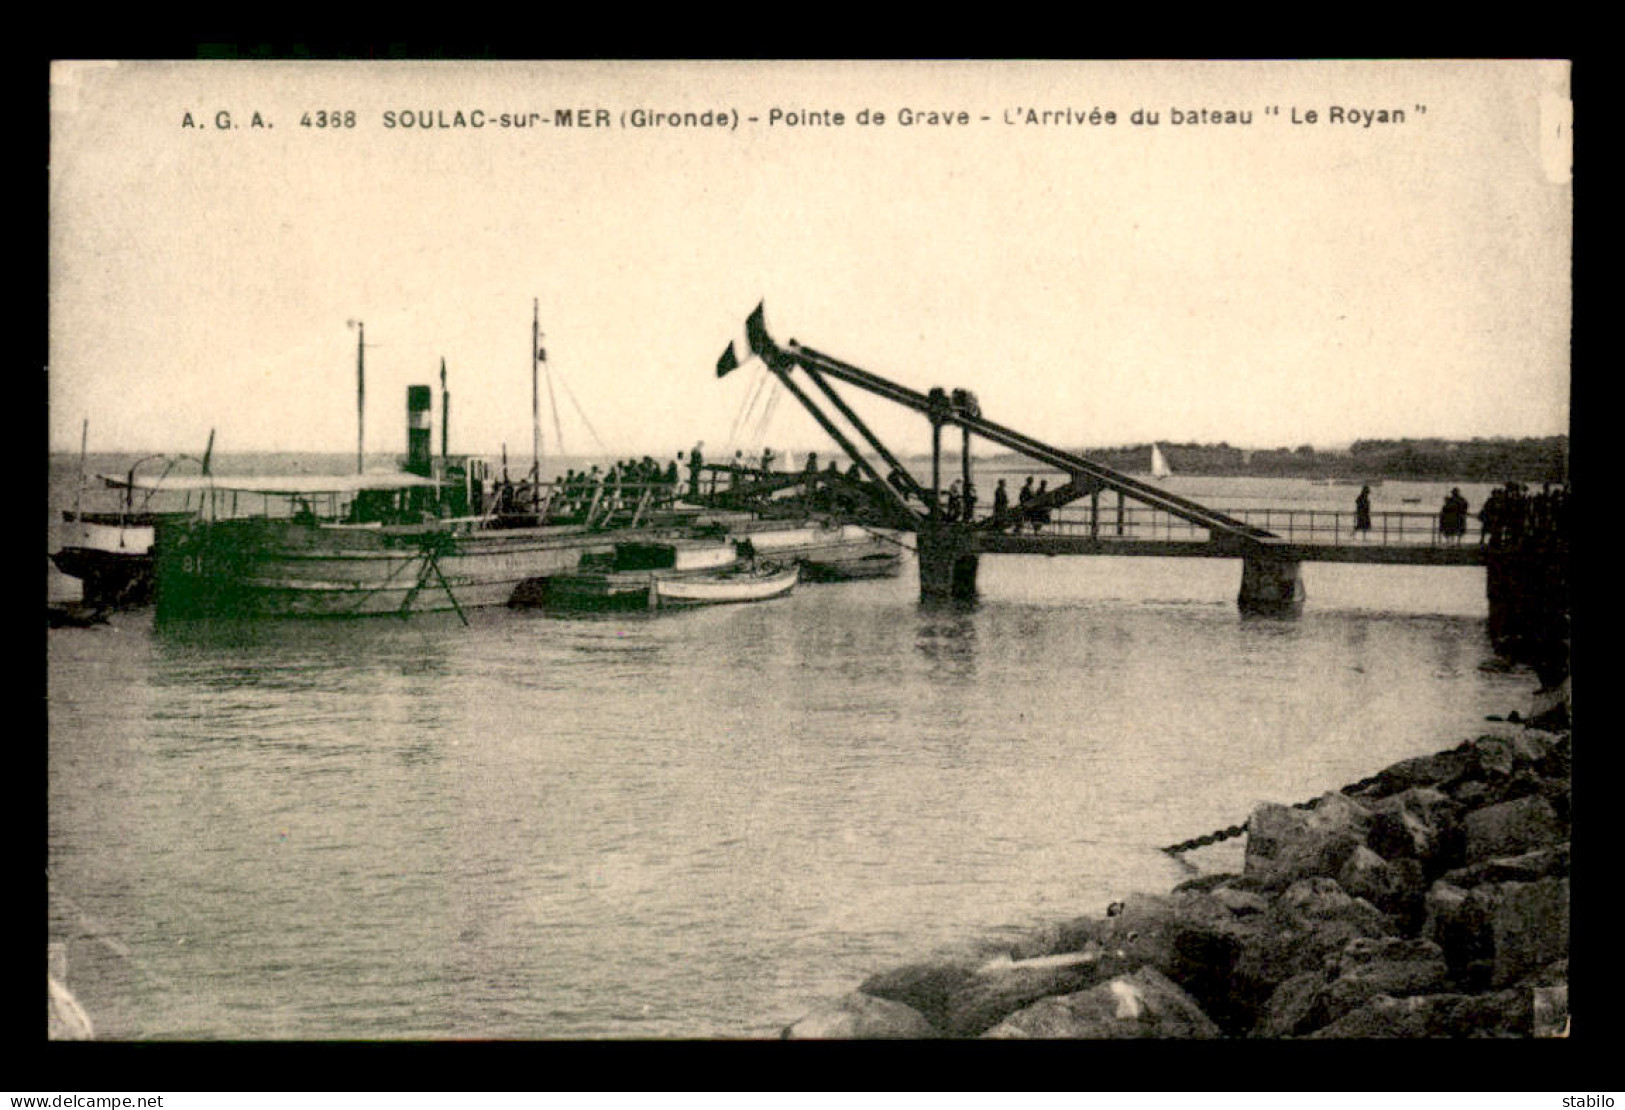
left=985, top=967, right=1220, bottom=1040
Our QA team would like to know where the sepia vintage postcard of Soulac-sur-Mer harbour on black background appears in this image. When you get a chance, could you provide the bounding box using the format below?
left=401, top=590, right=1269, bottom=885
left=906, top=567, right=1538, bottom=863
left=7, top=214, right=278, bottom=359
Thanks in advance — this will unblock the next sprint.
left=47, top=60, right=1573, bottom=1042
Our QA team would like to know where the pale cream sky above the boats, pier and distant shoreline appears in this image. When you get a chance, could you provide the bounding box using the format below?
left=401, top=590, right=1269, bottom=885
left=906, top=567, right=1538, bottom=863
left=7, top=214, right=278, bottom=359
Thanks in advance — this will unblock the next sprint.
left=47, top=62, right=1573, bottom=458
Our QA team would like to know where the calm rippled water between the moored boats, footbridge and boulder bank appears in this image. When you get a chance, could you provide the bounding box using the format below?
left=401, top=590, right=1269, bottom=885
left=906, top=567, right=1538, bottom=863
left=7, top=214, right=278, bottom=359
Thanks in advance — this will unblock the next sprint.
left=47, top=464, right=1534, bottom=1038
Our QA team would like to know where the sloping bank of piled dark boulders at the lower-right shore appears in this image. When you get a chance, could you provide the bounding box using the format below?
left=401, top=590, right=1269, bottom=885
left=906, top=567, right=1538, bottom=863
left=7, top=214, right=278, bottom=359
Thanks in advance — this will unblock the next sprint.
left=783, top=730, right=1570, bottom=1038
